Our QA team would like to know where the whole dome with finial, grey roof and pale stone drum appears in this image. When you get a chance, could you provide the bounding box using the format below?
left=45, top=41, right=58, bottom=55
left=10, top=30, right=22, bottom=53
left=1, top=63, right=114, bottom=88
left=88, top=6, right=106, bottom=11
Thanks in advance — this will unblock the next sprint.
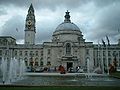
left=52, top=11, right=84, bottom=42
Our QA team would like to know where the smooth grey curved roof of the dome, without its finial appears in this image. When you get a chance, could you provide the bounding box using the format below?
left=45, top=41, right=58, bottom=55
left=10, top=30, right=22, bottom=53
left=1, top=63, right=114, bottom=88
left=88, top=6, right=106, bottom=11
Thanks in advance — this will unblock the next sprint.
left=56, top=22, right=80, bottom=31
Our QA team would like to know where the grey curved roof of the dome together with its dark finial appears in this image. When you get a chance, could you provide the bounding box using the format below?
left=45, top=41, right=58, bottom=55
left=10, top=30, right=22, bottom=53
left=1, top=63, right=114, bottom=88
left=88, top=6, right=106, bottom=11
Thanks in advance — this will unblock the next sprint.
left=55, top=11, right=80, bottom=31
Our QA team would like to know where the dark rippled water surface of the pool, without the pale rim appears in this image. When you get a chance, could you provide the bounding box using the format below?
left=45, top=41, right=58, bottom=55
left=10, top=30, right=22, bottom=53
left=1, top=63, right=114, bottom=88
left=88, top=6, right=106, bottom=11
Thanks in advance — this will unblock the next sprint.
left=12, top=75, right=120, bottom=86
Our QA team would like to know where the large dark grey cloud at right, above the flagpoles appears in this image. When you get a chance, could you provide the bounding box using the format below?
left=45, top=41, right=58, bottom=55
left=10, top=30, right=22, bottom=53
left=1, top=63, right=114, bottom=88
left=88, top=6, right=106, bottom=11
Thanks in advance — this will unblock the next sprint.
left=86, top=3, right=120, bottom=42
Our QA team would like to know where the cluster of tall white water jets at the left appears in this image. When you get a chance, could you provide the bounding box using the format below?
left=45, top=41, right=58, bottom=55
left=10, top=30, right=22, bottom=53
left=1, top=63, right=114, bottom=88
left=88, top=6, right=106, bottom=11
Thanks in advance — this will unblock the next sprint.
left=1, top=58, right=26, bottom=84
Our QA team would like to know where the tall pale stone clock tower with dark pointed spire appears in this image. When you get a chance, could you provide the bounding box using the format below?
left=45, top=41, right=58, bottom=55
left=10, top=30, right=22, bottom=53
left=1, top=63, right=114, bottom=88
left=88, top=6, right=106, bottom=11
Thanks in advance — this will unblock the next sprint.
left=25, top=4, right=36, bottom=45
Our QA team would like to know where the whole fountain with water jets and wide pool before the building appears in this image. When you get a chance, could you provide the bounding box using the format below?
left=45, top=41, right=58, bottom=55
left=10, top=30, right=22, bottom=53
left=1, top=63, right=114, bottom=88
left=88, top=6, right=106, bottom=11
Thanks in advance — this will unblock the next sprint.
left=1, top=58, right=120, bottom=86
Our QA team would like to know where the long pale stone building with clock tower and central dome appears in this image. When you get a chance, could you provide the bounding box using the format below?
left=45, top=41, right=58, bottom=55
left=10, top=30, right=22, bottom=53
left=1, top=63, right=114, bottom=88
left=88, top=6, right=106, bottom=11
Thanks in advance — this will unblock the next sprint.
left=0, top=4, right=120, bottom=70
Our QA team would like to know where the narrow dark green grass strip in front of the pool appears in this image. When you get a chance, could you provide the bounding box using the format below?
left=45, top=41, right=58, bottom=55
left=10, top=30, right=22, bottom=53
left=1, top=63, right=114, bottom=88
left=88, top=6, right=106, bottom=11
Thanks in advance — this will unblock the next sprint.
left=0, top=86, right=120, bottom=90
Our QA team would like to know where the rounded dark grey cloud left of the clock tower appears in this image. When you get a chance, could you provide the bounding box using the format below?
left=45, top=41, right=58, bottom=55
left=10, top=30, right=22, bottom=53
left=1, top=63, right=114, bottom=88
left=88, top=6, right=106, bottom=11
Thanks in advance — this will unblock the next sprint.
left=1, top=15, right=24, bottom=41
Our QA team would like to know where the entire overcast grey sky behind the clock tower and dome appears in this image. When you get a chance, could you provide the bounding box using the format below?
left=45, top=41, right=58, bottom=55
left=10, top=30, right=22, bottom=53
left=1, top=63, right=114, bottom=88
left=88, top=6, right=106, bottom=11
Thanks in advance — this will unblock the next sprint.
left=0, top=0, right=120, bottom=43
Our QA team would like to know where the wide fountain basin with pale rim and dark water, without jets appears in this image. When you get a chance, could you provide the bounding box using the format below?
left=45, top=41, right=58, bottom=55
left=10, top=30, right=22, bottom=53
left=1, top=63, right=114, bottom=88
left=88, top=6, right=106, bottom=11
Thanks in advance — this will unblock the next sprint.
left=6, top=73, right=120, bottom=86
